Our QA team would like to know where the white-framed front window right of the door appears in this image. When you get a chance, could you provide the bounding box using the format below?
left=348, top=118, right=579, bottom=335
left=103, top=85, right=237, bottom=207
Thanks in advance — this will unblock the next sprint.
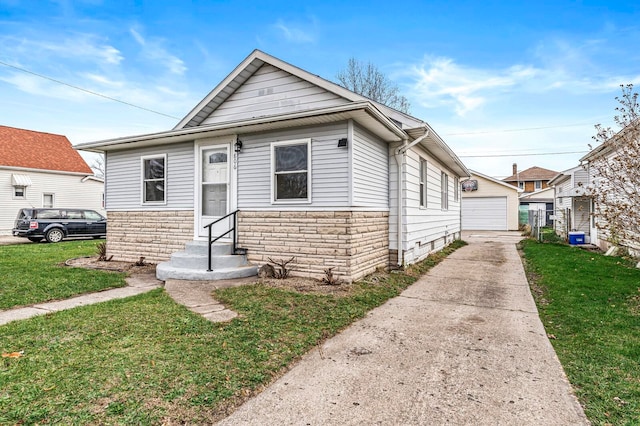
left=271, top=139, right=311, bottom=202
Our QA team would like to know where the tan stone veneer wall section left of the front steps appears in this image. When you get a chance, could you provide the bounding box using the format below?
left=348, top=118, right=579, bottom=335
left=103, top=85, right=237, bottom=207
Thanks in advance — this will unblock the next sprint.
left=107, top=210, right=193, bottom=263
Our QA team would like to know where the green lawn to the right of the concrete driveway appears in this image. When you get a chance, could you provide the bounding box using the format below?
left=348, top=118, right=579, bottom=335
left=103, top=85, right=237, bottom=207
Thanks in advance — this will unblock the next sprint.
left=523, top=240, right=640, bottom=425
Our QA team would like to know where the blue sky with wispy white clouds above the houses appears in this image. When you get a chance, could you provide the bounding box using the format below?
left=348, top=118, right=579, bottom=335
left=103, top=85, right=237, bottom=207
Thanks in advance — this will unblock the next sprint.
left=0, top=0, right=640, bottom=177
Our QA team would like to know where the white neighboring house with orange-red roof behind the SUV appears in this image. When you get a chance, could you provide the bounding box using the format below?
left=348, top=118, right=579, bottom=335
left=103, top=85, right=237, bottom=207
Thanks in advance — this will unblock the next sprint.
left=0, top=126, right=105, bottom=235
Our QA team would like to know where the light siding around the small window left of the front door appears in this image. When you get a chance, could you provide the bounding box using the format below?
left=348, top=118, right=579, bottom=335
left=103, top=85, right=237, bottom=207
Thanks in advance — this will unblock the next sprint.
left=106, top=142, right=195, bottom=210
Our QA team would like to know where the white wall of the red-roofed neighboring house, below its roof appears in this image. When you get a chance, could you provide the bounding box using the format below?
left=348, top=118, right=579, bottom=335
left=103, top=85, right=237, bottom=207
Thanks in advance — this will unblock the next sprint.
left=0, top=168, right=106, bottom=235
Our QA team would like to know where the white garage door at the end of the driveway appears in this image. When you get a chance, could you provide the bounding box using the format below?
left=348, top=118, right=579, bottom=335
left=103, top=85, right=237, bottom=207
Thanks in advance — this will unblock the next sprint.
left=462, top=197, right=507, bottom=231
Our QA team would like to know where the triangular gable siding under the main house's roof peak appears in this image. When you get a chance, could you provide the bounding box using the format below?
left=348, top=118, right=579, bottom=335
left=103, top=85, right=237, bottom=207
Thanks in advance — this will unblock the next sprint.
left=202, top=65, right=348, bottom=125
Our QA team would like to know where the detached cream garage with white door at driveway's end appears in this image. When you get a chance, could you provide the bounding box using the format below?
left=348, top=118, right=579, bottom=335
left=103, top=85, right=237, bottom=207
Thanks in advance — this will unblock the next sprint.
left=462, top=170, right=522, bottom=231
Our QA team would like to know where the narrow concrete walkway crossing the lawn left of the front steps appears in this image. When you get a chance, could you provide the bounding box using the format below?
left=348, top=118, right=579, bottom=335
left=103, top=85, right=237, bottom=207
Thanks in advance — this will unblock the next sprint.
left=0, top=274, right=162, bottom=325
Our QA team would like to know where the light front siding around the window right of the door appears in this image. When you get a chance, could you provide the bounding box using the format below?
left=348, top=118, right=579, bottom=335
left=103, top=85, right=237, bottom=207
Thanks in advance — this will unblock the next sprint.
left=237, top=122, right=349, bottom=209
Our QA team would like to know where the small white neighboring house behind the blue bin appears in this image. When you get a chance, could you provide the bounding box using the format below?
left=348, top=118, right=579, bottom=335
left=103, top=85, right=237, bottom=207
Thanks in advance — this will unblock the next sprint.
left=549, top=166, right=597, bottom=243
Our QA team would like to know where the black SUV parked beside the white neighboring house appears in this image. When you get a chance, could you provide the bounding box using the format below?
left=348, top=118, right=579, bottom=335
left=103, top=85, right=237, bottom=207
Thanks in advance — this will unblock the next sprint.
left=13, top=209, right=107, bottom=243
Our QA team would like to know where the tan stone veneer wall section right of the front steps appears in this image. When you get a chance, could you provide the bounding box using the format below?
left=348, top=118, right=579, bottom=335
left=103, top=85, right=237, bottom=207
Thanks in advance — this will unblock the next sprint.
left=238, top=210, right=389, bottom=282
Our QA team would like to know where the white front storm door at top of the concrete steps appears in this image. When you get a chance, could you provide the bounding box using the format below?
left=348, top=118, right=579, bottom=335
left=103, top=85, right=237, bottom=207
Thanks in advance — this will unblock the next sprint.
left=198, top=144, right=231, bottom=239
